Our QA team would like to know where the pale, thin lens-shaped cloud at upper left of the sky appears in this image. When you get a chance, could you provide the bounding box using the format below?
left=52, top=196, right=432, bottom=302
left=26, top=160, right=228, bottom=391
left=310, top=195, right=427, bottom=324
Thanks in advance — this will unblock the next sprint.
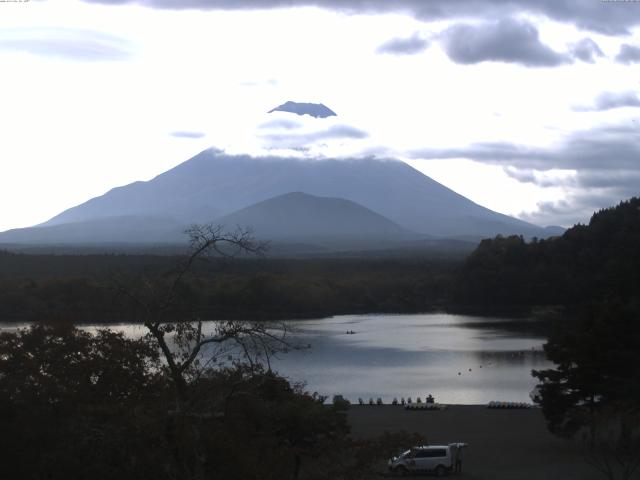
left=0, top=28, right=130, bottom=61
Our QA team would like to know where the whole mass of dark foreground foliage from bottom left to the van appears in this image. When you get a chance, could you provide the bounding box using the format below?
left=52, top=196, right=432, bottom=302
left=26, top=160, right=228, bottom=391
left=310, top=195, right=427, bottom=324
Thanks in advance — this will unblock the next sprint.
left=0, top=324, right=424, bottom=480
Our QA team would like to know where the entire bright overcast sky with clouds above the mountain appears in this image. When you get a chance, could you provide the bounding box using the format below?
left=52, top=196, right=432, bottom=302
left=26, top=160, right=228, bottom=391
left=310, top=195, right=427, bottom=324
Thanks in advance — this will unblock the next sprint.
left=0, top=0, right=640, bottom=231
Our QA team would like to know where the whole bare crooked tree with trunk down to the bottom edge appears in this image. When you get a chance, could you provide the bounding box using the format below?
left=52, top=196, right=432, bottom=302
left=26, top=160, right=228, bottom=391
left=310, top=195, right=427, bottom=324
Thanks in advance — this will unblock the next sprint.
left=117, top=225, right=296, bottom=480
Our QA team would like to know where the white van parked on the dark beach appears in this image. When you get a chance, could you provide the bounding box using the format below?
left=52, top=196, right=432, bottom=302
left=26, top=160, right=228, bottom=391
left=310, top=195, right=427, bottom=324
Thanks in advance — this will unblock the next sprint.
left=388, top=443, right=467, bottom=477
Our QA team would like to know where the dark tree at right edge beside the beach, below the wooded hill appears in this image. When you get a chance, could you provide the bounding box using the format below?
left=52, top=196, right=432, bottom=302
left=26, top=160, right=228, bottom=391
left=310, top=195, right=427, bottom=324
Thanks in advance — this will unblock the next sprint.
left=533, top=302, right=640, bottom=436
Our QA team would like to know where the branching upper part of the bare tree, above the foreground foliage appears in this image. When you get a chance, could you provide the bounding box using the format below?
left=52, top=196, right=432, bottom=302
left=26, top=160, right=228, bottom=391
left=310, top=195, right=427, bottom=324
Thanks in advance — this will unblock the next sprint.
left=118, top=225, right=294, bottom=404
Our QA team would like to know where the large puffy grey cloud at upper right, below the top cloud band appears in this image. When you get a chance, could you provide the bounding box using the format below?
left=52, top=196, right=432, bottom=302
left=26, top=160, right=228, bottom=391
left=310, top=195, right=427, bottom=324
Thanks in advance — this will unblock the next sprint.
left=441, top=19, right=571, bottom=67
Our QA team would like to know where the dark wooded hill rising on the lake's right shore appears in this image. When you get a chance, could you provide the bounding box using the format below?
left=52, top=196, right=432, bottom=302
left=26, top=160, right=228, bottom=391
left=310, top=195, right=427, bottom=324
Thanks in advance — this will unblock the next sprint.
left=453, top=198, right=640, bottom=308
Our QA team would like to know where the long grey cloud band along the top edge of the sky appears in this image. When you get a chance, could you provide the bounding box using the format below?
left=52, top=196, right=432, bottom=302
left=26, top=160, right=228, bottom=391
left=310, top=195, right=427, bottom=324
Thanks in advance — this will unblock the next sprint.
left=85, top=0, right=640, bottom=35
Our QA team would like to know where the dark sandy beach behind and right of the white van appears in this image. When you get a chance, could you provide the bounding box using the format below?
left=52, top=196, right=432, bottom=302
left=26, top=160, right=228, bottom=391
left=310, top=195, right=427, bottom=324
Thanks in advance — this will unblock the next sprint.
left=349, top=405, right=604, bottom=480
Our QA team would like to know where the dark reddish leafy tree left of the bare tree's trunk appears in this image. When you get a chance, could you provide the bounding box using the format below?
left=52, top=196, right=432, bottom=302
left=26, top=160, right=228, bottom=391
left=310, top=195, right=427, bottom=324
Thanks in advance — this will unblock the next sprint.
left=0, top=325, right=166, bottom=478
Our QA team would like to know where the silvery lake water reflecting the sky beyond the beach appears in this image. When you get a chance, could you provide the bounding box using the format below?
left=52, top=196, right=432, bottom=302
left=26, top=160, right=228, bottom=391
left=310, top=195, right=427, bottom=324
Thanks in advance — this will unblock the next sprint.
left=0, top=314, right=550, bottom=404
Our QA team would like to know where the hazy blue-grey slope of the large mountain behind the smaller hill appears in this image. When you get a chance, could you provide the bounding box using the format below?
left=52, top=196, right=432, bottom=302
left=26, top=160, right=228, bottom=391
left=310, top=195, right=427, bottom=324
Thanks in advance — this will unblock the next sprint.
left=38, top=150, right=547, bottom=237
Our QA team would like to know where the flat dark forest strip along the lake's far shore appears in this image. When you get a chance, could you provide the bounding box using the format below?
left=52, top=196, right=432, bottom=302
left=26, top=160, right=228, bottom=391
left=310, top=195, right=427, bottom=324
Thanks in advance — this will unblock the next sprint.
left=0, top=252, right=459, bottom=323
